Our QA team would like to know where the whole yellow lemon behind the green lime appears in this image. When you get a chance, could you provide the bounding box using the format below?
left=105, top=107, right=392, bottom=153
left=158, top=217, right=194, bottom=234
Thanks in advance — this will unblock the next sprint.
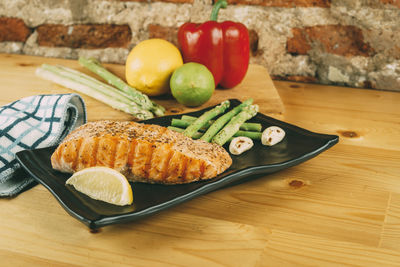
left=125, top=38, right=183, bottom=96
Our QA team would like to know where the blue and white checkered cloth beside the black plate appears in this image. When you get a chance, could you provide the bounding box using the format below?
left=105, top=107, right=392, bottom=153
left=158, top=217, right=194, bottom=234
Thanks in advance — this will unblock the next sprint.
left=0, top=94, right=86, bottom=197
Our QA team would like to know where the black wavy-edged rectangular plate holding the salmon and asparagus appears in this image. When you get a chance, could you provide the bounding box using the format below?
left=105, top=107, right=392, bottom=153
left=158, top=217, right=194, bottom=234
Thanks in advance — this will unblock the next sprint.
left=17, top=100, right=339, bottom=229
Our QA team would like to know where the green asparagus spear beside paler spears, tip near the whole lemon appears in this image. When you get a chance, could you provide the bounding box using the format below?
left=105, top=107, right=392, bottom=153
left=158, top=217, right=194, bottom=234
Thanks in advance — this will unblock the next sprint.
left=79, top=57, right=165, bottom=116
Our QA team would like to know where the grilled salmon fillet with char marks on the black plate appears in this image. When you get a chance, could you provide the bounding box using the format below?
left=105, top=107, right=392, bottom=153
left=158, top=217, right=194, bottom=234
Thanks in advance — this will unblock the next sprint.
left=51, top=121, right=232, bottom=184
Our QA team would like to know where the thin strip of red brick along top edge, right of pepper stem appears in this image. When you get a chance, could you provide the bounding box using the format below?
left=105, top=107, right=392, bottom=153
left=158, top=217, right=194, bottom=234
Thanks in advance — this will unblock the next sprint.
left=223, top=0, right=331, bottom=7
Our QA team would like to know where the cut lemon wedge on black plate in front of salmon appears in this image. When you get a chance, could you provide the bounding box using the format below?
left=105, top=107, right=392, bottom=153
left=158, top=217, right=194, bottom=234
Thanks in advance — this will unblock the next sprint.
left=66, top=167, right=133, bottom=206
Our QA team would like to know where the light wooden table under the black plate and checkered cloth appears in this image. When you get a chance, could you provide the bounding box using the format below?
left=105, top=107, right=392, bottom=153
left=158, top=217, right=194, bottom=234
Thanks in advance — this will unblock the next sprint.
left=0, top=55, right=400, bottom=266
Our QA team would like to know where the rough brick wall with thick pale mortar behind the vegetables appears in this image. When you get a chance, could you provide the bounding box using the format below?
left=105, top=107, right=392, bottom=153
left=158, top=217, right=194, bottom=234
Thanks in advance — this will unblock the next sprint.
left=0, top=0, right=400, bottom=91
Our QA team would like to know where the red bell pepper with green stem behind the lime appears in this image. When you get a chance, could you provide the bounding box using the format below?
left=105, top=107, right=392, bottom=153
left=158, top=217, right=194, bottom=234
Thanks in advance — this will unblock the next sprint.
left=178, top=0, right=250, bottom=88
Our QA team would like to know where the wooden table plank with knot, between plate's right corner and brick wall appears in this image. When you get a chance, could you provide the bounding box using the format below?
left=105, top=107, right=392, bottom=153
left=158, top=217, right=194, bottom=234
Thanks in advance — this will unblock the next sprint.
left=275, top=82, right=400, bottom=151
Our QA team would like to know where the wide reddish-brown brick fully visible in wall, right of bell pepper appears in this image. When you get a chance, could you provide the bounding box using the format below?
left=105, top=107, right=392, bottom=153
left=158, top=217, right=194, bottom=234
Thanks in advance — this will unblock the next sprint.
left=287, top=25, right=375, bottom=57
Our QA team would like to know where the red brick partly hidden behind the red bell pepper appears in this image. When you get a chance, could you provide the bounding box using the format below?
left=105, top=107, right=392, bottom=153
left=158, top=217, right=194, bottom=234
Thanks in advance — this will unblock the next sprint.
left=148, top=24, right=262, bottom=56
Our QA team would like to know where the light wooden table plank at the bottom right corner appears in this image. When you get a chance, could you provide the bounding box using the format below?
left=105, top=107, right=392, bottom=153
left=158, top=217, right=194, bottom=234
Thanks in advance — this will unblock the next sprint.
left=257, top=231, right=400, bottom=267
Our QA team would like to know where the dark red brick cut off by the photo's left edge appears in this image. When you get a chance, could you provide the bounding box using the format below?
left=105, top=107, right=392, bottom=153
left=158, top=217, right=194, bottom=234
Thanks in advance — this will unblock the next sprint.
left=0, top=17, right=31, bottom=42
